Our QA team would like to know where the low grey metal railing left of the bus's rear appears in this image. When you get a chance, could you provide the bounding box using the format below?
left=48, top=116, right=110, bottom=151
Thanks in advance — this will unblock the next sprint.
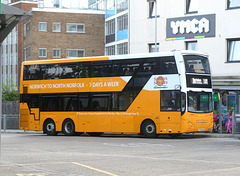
left=1, top=114, right=19, bottom=131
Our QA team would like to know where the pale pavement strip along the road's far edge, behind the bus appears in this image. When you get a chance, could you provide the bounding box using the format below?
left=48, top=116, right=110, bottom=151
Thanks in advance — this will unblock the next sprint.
left=1, top=129, right=240, bottom=139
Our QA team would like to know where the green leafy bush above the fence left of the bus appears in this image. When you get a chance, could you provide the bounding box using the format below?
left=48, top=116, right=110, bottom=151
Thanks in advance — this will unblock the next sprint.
left=2, top=80, right=19, bottom=101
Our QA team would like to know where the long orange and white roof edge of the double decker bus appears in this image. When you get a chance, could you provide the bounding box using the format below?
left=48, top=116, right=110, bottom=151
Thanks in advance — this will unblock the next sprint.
left=23, top=50, right=208, bottom=65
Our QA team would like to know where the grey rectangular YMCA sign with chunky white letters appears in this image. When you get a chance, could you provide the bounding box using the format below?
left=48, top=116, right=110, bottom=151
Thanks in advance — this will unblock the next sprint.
left=166, top=14, right=215, bottom=40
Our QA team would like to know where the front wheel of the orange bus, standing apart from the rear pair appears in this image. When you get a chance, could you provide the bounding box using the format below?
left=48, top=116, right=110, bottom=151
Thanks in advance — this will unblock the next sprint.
left=141, top=120, right=157, bottom=138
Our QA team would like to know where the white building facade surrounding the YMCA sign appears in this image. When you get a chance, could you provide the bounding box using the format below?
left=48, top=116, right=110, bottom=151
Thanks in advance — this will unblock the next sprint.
left=129, top=0, right=240, bottom=90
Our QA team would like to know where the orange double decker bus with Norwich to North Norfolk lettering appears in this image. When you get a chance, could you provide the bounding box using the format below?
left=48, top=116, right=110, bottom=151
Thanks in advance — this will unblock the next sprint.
left=20, top=51, right=213, bottom=137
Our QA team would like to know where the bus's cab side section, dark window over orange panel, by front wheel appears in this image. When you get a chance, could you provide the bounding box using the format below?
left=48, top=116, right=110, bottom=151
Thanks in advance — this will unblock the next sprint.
left=160, top=90, right=181, bottom=133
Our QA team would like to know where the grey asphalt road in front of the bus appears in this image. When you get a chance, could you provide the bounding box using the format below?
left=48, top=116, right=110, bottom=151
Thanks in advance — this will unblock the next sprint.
left=0, top=133, right=240, bottom=176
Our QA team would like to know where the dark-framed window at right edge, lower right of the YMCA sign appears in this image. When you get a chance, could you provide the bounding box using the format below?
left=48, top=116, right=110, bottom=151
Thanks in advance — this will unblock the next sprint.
left=228, top=39, right=240, bottom=62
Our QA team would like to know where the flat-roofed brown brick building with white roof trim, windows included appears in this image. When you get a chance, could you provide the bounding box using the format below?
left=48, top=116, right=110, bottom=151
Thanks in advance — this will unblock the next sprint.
left=23, top=8, right=105, bottom=60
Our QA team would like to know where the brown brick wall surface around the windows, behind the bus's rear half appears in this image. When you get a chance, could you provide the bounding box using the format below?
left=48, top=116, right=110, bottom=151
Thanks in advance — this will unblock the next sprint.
left=24, top=11, right=105, bottom=60
